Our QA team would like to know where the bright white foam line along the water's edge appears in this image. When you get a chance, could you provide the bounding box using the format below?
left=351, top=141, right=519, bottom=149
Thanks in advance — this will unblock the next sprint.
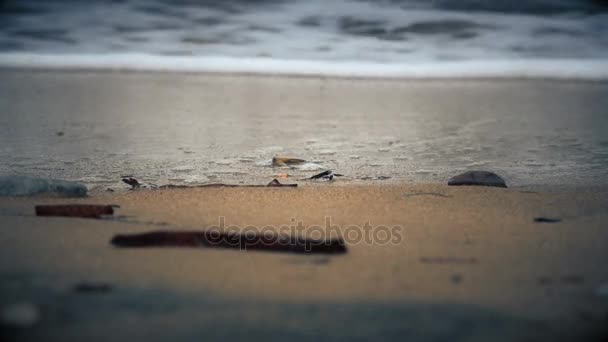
left=0, top=53, right=608, bottom=80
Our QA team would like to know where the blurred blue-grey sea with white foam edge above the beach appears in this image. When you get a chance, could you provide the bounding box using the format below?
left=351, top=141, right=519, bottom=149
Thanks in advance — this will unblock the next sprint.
left=0, top=0, right=608, bottom=79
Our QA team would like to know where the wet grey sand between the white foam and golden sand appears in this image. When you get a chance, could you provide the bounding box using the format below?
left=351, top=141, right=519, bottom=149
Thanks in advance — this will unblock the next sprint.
left=0, top=69, right=608, bottom=190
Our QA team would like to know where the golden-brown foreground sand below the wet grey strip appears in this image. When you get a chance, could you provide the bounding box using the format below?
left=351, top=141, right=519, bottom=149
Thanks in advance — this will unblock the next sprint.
left=0, top=183, right=608, bottom=341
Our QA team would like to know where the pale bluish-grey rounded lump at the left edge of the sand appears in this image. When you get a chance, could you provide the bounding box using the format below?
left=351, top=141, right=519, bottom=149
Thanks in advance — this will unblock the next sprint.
left=0, top=176, right=87, bottom=197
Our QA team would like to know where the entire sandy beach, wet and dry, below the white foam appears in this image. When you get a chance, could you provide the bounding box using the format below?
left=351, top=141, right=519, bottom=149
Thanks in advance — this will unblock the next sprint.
left=0, top=70, right=608, bottom=341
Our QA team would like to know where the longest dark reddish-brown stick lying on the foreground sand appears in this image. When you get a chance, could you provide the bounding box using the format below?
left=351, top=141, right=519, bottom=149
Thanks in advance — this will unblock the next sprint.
left=111, top=231, right=346, bottom=254
